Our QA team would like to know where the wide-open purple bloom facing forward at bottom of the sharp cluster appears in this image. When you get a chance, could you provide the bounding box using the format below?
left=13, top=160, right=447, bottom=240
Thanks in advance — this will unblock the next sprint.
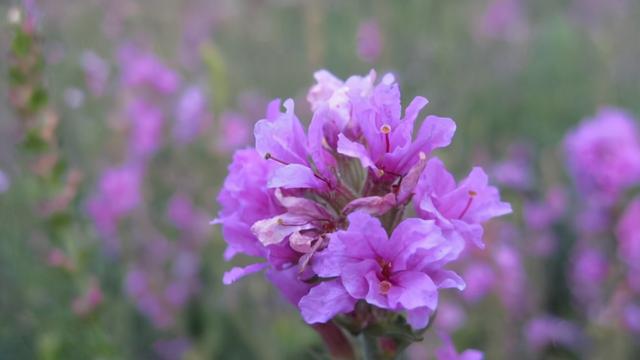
left=299, top=212, right=464, bottom=329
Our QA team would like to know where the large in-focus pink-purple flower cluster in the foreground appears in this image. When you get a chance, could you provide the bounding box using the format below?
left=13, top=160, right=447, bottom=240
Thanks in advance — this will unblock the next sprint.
left=214, top=71, right=511, bottom=329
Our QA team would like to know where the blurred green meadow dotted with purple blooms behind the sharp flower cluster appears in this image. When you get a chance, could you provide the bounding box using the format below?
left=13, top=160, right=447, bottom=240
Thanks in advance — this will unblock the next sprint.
left=0, top=0, right=640, bottom=359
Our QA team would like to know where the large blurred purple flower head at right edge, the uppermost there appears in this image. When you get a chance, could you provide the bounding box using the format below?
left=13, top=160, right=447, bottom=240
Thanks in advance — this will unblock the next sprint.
left=564, top=107, right=640, bottom=204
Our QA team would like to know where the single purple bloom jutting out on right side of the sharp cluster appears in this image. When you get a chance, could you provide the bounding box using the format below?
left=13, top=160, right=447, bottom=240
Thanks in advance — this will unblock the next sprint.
left=414, top=158, right=511, bottom=247
